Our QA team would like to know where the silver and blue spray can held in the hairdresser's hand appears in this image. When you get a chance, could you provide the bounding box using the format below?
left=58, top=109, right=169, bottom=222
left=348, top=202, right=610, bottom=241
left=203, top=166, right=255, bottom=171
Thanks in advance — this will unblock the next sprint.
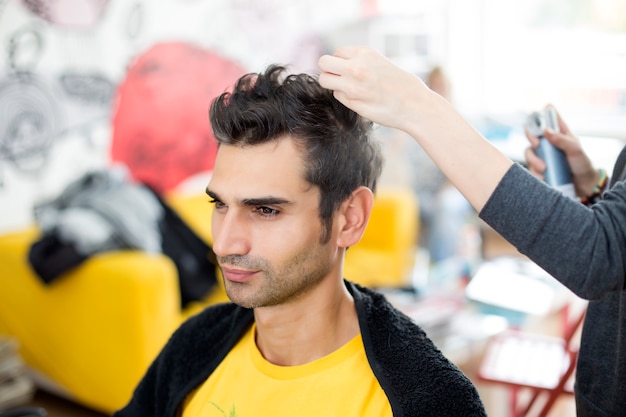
left=526, top=108, right=576, bottom=199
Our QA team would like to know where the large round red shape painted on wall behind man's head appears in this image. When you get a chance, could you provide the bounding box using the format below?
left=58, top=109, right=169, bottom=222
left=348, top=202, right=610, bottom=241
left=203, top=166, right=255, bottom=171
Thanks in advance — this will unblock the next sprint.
left=111, top=42, right=245, bottom=193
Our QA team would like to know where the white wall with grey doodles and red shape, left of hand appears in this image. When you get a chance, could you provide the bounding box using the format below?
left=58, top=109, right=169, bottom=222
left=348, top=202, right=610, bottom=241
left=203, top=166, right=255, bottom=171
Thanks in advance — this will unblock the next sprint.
left=0, top=0, right=359, bottom=233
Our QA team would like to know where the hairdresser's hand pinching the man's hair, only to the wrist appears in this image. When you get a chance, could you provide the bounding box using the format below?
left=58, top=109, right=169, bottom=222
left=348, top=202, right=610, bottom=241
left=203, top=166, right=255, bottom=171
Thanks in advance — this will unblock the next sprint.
left=318, top=47, right=438, bottom=131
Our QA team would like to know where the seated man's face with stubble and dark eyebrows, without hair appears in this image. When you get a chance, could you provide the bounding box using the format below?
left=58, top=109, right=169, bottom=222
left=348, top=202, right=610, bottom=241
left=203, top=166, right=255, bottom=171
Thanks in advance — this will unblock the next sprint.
left=207, top=137, right=340, bottom=308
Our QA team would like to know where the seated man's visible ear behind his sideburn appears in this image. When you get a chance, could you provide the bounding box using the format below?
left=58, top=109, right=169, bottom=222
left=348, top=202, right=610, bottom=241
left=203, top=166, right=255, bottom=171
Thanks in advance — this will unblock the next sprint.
left=337, top=186, right=374, bottom=248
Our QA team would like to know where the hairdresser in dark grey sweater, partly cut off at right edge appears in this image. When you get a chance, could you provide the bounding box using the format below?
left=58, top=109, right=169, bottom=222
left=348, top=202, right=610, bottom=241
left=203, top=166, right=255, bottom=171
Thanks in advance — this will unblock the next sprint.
left=319, top=47, right=626, bottom=417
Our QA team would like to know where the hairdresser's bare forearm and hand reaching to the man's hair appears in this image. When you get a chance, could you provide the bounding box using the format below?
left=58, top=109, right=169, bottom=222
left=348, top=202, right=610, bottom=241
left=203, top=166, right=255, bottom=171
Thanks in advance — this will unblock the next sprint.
left=318, top=47, right=512, bottom=211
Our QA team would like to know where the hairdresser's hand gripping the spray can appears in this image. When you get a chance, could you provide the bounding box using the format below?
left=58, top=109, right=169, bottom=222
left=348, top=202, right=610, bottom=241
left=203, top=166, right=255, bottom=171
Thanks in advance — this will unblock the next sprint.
left=525, top=105, right=600, bottom=197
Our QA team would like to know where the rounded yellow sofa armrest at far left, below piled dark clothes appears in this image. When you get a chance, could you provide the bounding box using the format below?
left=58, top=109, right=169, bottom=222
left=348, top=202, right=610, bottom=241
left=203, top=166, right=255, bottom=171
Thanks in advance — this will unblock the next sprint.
left=0, top=228, right=181, bottom=412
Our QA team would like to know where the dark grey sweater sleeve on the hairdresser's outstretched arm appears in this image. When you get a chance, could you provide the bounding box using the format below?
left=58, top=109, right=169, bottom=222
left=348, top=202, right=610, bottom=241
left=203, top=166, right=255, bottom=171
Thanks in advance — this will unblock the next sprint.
left=479, top=164, right=626, bottom=300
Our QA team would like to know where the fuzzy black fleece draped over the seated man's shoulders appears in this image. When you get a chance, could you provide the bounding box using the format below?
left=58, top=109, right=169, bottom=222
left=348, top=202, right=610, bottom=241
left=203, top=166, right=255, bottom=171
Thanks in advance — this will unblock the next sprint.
left=114, top=282, right=486, bottom=417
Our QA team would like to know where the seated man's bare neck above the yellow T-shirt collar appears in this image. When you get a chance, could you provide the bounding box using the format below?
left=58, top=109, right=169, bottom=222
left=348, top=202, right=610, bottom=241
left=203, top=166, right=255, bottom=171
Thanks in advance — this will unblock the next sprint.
left=254, top=282, right=359, bottom=366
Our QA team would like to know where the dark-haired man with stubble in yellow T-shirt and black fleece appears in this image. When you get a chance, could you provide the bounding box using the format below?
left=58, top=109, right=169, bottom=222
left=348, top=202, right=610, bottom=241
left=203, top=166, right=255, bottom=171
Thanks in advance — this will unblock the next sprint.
left=116, top=66, right=485, bottom=417
